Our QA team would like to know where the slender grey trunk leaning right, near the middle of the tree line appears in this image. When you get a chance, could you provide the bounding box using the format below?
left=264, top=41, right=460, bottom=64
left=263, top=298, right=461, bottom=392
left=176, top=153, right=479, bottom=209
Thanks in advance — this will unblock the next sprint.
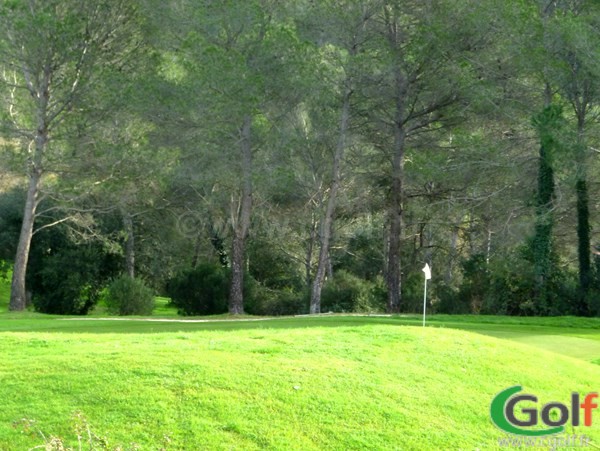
left=310, top=88, right=352, bottom=313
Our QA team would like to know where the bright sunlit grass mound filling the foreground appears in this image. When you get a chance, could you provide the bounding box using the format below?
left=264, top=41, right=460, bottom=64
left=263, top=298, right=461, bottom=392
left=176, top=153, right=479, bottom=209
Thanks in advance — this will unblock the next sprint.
left=0, top=317, right=600, bottom=450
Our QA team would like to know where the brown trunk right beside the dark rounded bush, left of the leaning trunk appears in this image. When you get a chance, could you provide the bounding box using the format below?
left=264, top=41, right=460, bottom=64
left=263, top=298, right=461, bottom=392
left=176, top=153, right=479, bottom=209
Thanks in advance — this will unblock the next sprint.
left=229, top=116, right=252, bottom=315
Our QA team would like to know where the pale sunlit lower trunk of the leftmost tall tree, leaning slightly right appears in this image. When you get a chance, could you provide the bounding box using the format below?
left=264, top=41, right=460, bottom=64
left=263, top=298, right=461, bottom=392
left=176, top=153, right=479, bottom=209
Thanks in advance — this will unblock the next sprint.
left=8, top=168, right=41, bottom=311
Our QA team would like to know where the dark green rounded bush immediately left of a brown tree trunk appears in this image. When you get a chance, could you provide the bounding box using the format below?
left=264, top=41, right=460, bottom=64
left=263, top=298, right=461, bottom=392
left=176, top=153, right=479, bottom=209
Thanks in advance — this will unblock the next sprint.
left=167, top=263, right=229, bottom=315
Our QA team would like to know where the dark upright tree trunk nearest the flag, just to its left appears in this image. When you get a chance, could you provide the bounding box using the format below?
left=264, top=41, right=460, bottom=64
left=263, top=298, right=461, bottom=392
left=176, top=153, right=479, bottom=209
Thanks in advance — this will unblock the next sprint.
left=386, top=72, right=406, bottom=313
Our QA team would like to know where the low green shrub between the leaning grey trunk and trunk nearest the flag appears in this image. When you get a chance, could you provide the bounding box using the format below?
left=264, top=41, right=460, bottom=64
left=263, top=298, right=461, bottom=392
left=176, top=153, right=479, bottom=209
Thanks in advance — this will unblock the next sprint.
left=321, top=270, right=385, bottom=312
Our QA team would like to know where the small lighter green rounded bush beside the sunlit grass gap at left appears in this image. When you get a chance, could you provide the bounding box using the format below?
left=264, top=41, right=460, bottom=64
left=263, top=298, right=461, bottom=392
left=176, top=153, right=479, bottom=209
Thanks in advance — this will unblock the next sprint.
left=106, top=275, right=155, bottom=316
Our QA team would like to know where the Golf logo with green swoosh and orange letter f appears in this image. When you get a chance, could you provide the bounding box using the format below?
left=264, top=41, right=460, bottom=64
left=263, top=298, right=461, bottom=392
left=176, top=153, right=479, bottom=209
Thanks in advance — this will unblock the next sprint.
left=490, top=385, right=598, bottom=437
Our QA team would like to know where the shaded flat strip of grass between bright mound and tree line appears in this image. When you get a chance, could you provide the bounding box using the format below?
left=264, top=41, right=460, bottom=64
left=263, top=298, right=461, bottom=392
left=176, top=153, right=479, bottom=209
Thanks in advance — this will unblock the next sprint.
left=0, top=312, right=600, bottom=363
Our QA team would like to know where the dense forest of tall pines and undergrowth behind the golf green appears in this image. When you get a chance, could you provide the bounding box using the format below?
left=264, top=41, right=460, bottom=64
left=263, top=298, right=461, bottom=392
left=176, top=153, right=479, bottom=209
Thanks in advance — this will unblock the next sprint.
left=0, top=0, right=600, bottom=316
